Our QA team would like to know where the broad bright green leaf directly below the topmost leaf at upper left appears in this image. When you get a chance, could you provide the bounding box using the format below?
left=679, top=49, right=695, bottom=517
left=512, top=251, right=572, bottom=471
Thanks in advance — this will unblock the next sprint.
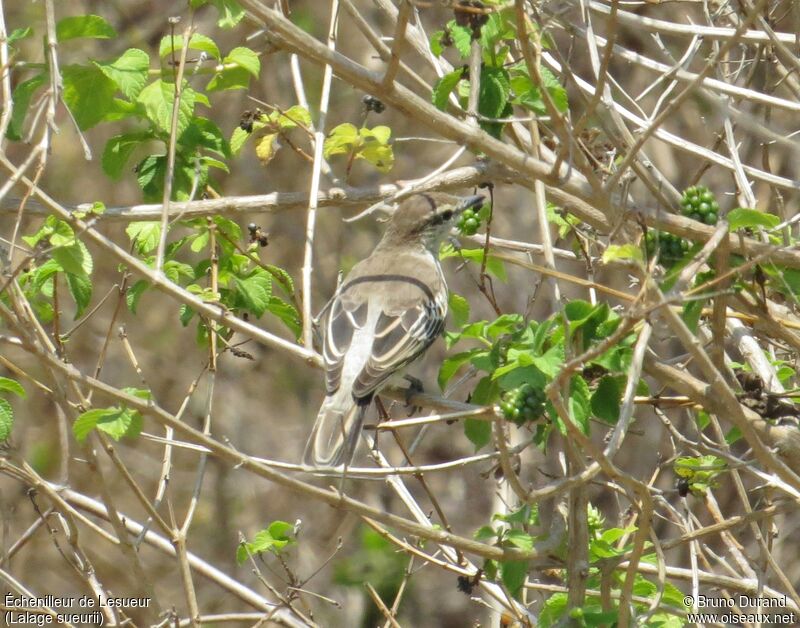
left=61, top=65, right=117, bottom=131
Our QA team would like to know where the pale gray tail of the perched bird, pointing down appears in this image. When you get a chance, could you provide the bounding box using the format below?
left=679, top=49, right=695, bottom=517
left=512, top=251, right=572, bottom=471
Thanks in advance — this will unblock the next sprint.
left=303, top=394, right=369, bottom=468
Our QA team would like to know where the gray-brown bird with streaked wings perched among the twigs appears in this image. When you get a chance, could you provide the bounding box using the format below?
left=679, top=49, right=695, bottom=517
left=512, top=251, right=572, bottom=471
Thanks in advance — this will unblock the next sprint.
left=303, top=193, right=484, bottom=468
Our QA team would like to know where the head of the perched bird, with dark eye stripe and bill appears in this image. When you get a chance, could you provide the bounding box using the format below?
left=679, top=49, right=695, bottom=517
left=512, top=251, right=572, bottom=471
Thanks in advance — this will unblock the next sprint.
left=382, top=192, right=485, bottom=252
